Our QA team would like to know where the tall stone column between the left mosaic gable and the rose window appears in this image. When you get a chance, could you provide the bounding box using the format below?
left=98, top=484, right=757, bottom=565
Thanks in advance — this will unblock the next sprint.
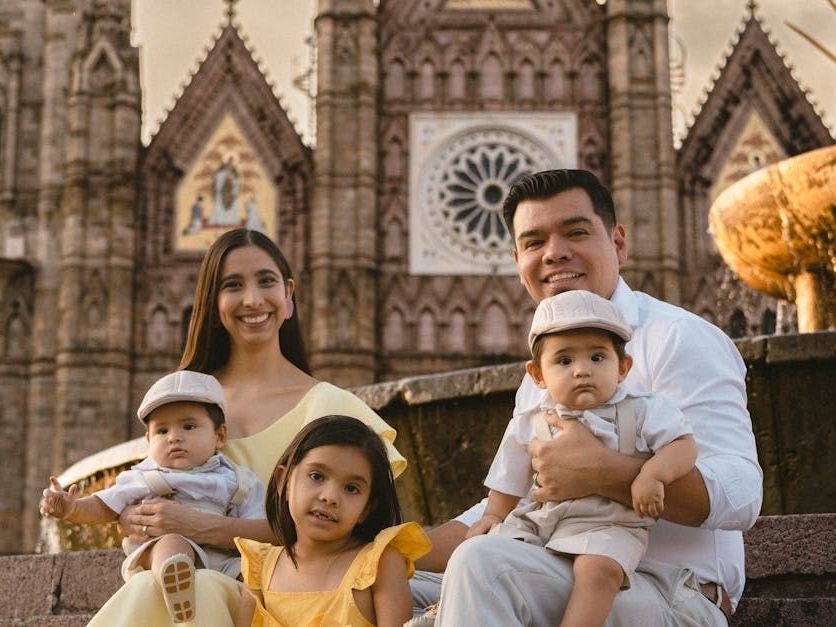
left=308, top=0, right=378, bottom=386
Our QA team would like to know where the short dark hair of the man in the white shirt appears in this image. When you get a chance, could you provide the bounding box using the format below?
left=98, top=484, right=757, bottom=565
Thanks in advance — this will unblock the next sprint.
left=502, top=170, right=616, bottom=239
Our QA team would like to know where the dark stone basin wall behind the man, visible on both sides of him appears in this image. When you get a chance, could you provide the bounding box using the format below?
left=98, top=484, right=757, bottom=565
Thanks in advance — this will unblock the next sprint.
left=355, top=331, right=836, bottom=524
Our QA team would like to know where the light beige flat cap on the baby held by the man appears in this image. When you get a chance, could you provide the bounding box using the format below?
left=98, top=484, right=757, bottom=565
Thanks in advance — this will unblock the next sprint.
left=528, top=290, right=633, bottom=349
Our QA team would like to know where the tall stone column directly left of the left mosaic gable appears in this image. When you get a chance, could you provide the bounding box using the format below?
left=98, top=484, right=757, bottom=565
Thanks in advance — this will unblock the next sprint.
left=52, top=0, right=140, bottom=486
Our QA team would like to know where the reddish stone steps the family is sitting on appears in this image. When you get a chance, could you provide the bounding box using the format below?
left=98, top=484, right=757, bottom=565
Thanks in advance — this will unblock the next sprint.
left=0, top=514, right=836, bottom=627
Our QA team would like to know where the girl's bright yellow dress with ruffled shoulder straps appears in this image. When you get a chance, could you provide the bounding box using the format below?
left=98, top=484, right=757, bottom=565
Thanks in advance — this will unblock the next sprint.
left=235, top=523, right=430, bottom=627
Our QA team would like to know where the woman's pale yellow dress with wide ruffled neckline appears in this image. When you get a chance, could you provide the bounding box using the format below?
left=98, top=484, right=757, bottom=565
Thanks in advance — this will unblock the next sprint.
left=88, top=382, right=406, bottom=627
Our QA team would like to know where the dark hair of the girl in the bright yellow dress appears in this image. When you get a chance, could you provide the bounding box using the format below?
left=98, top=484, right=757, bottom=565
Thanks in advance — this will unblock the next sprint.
left=265, top=416, right=403, bottom=564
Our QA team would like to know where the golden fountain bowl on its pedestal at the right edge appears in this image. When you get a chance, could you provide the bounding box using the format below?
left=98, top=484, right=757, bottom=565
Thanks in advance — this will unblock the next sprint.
left=708, top=146, right=836, bottom=333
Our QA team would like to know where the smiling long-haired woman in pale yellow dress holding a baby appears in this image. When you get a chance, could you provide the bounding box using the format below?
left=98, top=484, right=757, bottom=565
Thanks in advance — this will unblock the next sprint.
left=89, top=229, right=406, bottom=627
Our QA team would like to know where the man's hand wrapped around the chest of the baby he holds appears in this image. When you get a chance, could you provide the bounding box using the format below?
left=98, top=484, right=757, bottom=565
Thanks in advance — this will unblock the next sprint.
left=528, top=414, right=612, bottom=502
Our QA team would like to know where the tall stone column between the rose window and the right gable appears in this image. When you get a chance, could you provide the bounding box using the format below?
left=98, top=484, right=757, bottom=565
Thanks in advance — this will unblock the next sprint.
left=607, top=0, right=680, bottom=303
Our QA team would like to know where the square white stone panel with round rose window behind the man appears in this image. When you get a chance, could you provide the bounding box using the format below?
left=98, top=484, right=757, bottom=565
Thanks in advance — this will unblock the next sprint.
left=410, top=114, right=577, bottom=274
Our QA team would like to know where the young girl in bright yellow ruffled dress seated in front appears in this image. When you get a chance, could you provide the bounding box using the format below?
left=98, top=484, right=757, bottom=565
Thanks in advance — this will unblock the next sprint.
left=235, top=416, right=430, bottom=627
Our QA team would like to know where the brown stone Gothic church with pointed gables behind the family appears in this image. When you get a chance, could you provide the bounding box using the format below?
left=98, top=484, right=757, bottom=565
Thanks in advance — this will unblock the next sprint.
left=0, top=0, right=833, bottom=552
